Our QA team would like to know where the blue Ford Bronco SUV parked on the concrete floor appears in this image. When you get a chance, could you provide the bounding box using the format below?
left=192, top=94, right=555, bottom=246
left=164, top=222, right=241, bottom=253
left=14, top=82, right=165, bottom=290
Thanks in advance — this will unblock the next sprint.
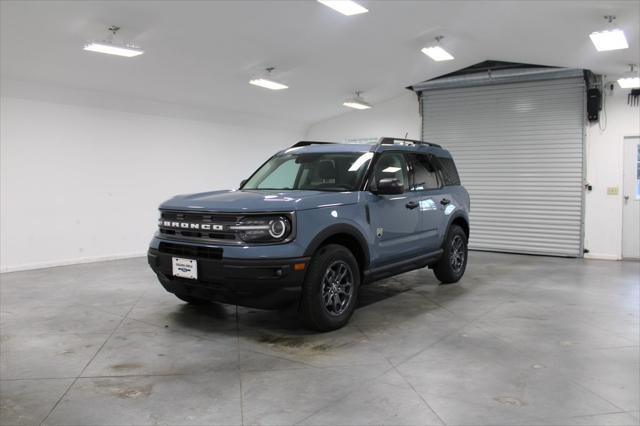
left=148, top=138, right=470, bottom=331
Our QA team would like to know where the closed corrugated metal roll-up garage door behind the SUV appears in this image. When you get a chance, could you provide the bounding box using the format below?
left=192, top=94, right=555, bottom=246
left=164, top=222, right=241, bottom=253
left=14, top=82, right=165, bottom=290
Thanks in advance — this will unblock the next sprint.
left=421, top=77, right=585, bottom=257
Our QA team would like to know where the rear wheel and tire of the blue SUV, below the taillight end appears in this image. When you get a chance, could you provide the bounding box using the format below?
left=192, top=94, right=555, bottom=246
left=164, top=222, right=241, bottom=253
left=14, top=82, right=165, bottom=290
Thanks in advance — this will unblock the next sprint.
left=433, top=225, right=468, bottom=284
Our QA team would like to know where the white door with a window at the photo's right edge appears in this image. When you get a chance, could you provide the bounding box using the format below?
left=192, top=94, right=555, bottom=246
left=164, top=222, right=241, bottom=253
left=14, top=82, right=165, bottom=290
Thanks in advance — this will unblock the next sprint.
left=622, top=136, right=640, bottom=259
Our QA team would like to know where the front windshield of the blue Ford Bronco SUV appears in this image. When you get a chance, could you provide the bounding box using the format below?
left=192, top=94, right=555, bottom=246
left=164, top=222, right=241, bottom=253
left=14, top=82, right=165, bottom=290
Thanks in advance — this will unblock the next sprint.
left=242, top=152, right=373, bottom=191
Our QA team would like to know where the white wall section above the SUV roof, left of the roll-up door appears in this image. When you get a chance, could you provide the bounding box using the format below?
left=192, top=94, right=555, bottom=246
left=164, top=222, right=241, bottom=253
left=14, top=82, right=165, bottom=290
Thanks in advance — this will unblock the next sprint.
left=307, top=91, right=421, bottom=142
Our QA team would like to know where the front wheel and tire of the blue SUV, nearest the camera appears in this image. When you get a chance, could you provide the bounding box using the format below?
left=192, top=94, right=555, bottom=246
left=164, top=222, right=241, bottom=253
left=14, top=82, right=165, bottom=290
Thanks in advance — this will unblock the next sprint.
left=300, top=244, right=360, bottom=331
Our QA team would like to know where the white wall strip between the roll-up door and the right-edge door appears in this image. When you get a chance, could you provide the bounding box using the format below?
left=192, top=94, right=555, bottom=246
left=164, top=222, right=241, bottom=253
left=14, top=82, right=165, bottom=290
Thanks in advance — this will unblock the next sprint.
left=584, top=89, right=640, bottom=259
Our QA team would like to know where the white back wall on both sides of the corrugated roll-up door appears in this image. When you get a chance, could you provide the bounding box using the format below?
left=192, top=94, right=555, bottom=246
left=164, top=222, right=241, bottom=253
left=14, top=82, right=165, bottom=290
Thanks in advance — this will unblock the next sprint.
left=307, top=87, right=640, bottom=259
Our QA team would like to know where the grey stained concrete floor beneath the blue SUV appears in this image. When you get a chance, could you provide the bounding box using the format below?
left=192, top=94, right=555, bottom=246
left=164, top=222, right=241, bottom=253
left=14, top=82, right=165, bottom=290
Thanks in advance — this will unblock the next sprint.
left=0, top=252, right=640, bottom=425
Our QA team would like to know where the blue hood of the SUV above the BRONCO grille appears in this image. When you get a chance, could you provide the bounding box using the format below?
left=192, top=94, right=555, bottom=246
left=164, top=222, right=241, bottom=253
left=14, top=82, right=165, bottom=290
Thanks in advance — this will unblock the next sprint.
left=160, top=190, right=358, bottom=213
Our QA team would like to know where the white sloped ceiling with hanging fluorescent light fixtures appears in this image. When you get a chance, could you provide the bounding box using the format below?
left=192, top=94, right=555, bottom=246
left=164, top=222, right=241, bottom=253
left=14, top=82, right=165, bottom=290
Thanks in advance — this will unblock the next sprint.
left=0, top=0, right=640, bottom=124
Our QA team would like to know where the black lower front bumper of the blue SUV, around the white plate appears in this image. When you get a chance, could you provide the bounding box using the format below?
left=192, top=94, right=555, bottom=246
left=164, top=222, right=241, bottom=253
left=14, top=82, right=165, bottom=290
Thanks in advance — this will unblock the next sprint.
left=147, top=246, right=309, bottom=309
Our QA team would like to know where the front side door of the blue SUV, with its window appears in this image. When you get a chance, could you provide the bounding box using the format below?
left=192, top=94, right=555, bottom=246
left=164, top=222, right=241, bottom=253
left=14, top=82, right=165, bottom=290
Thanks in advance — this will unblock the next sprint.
left=368, top=152, right=424, bottom=266
